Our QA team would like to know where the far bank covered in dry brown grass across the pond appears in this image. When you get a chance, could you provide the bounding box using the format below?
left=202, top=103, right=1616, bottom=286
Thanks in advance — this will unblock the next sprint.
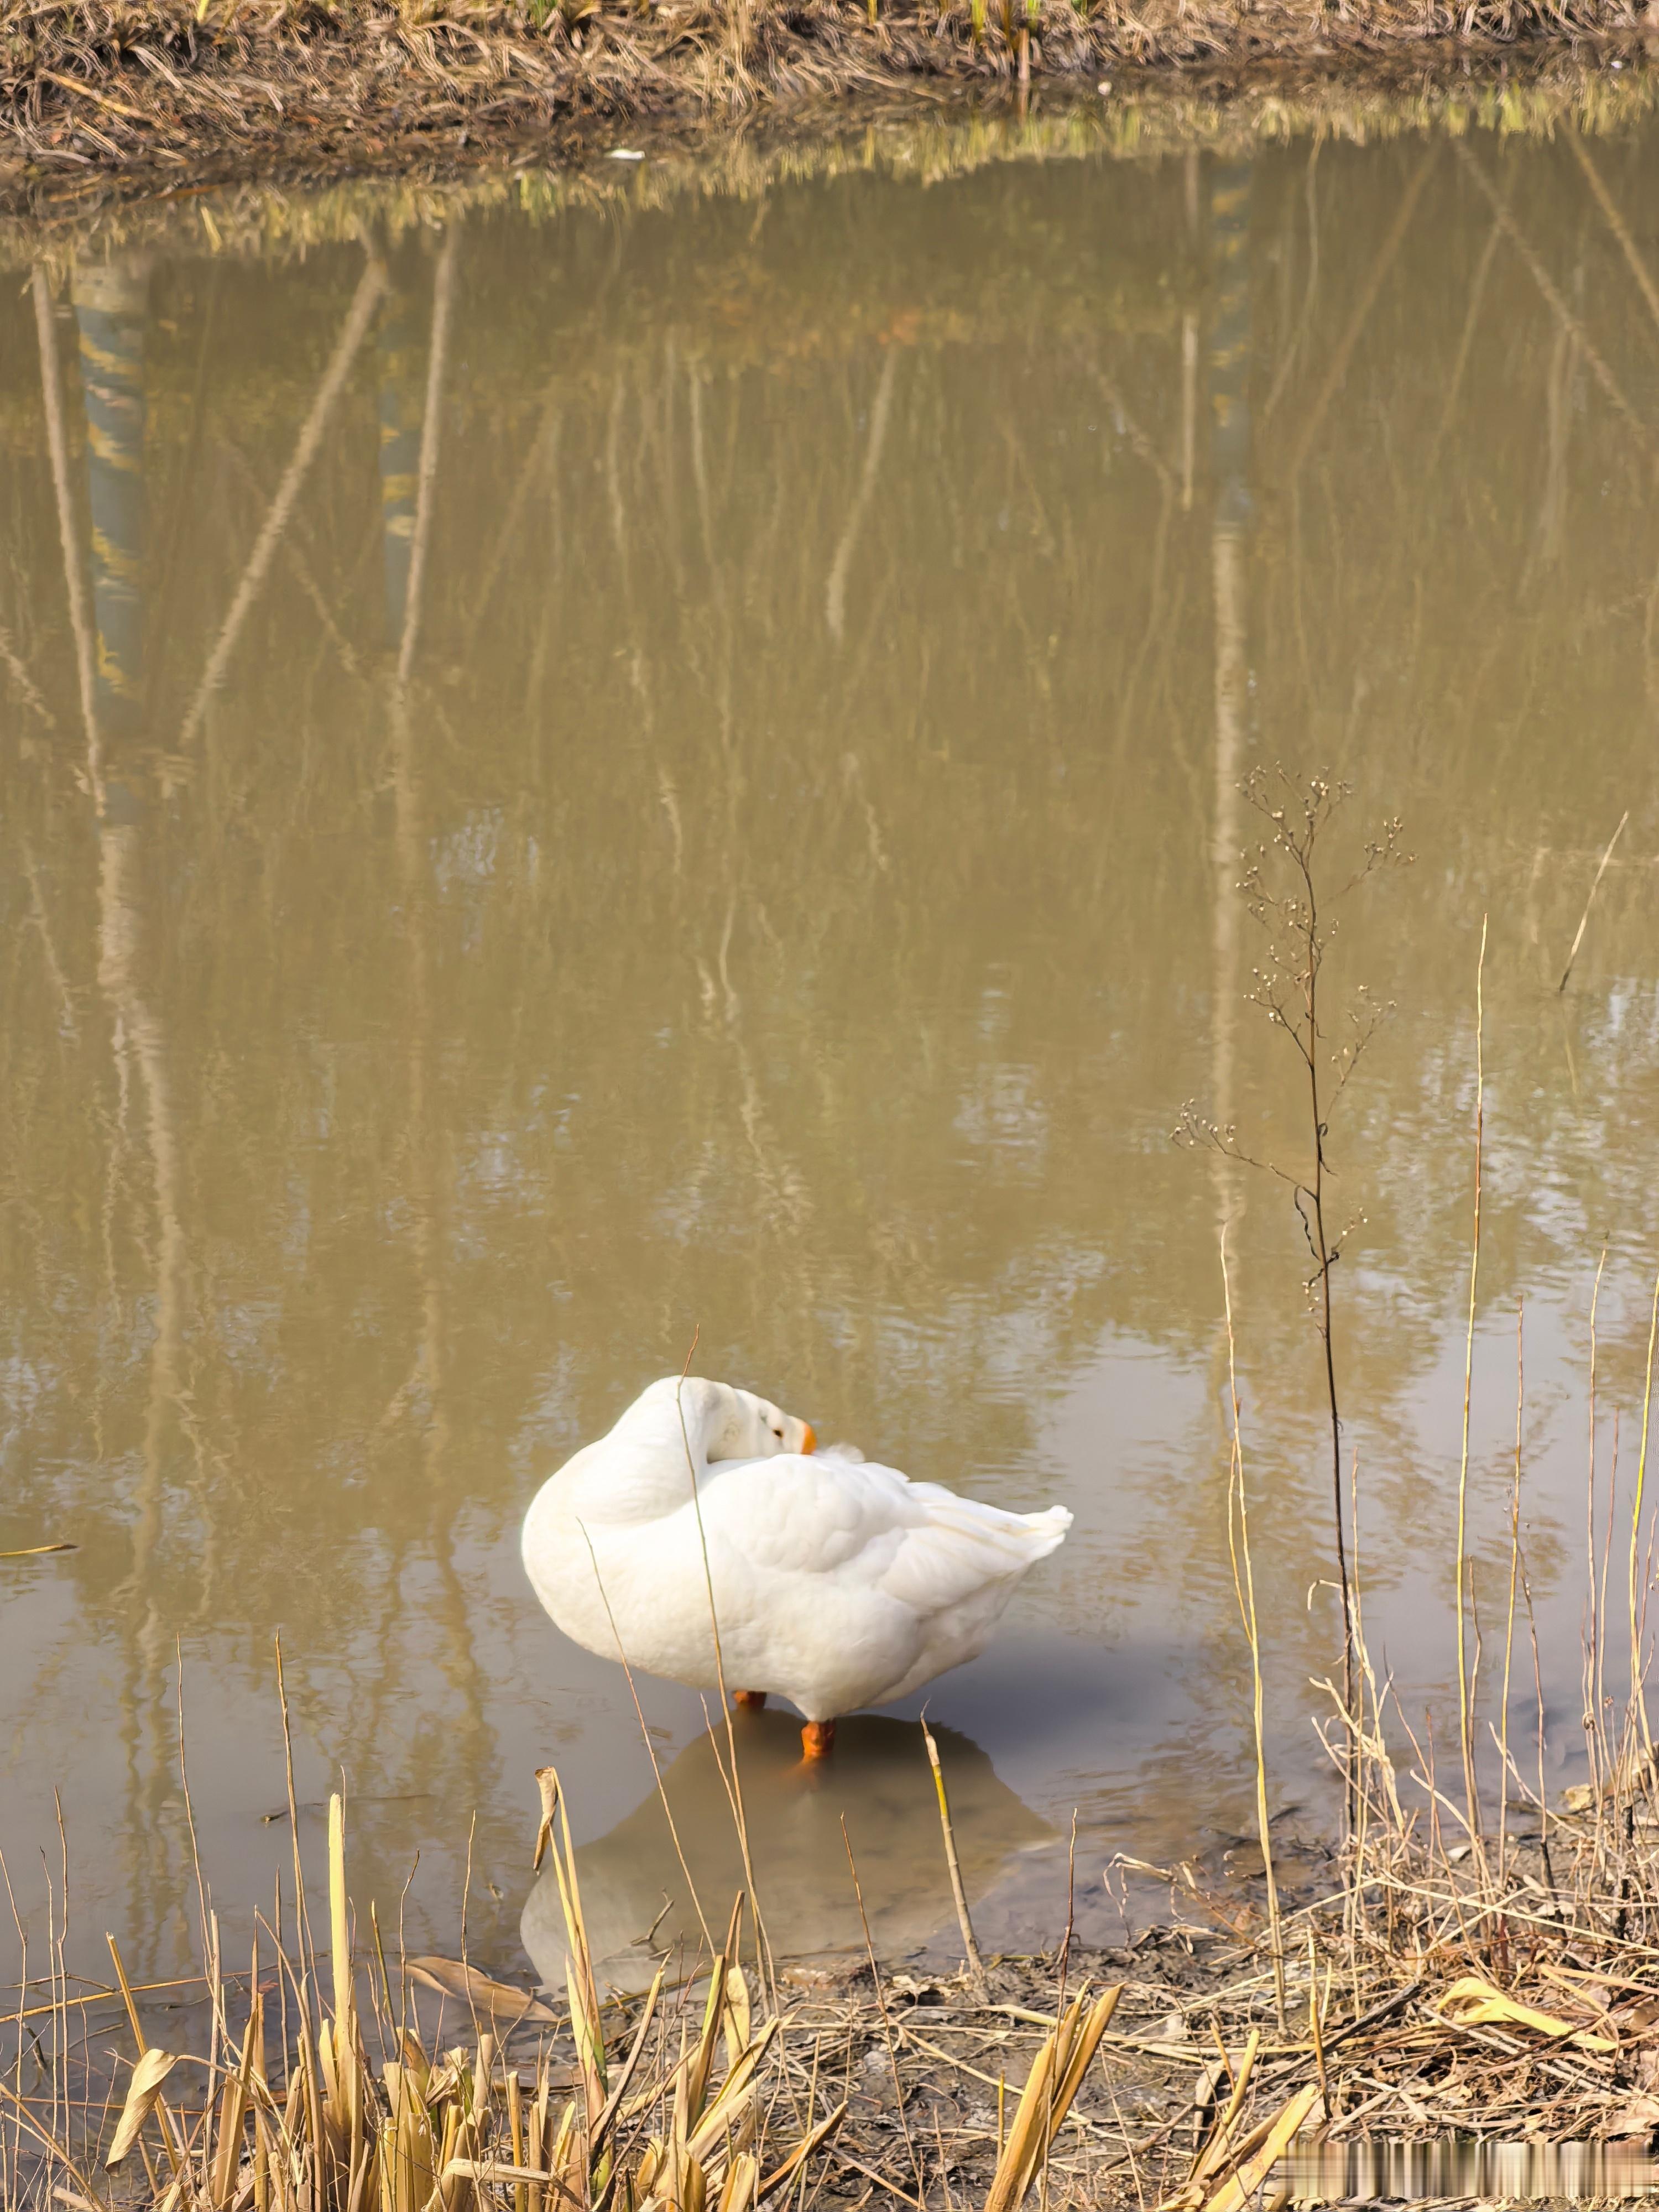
left=0, top=0, right=1659, bottom=201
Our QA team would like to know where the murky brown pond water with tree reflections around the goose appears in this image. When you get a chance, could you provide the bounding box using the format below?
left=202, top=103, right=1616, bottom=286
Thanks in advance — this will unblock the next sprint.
left=0, top=100, right=1659, bottom=1978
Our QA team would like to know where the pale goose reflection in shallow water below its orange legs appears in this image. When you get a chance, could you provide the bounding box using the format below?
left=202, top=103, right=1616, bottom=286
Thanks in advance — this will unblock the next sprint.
left=522, top=1712, right=1053, bottom=1991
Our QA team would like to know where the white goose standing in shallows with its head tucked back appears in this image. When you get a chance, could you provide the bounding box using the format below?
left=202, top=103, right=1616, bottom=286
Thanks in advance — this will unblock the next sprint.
left=524, top=1376, right=1071, bottom=1759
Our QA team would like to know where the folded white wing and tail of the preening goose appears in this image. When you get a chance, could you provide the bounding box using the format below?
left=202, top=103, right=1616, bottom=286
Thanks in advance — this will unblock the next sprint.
left=701, top=1453, right=1071, bottom=1613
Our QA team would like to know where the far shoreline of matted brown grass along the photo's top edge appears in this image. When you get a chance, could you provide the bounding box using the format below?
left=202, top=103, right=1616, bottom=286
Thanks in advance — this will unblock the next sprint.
left=0, top=0, right=1659, bottom=215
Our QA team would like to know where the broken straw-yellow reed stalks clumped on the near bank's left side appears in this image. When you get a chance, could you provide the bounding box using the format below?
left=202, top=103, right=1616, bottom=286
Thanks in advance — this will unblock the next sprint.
left=0, top=1770, right=1119, bottom=2212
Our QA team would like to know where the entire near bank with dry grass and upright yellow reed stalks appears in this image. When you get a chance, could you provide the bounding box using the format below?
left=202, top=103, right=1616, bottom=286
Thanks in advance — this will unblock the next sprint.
left=16, top=1741, right=1659, bottom=2212
